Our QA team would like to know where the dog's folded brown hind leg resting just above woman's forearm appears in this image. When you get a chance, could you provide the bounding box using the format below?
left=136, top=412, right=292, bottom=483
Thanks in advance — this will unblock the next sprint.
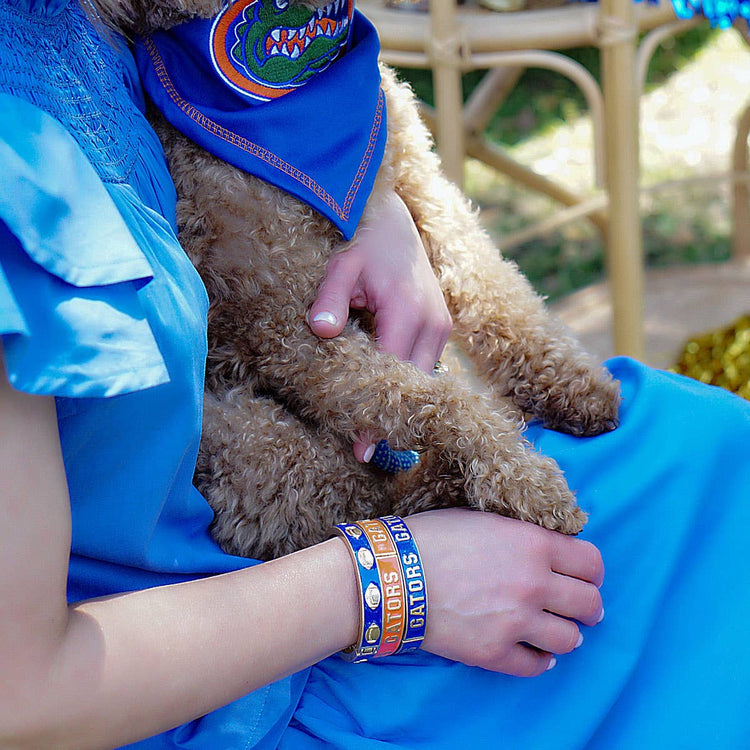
left=194, top=387, right=390, bottom=560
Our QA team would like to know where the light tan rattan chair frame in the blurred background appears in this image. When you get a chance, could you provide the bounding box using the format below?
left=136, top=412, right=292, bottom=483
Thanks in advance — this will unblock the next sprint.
left=359, top=0, right=728, bottom=358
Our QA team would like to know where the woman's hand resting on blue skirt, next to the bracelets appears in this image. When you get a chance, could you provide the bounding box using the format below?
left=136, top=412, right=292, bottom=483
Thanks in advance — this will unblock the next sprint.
left=407, top=508, right=604, bottom=677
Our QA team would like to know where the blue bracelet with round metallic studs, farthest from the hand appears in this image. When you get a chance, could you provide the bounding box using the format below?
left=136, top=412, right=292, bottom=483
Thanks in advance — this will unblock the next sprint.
left=334, top=523, right=383, bottom=662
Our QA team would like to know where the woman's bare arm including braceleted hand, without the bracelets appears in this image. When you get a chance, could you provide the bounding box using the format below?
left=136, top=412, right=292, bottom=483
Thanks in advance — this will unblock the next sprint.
left=0, top=342, right=603, bottom=750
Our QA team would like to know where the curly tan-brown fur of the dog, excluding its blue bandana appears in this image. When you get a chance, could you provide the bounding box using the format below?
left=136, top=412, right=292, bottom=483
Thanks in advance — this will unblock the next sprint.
left=94, top=0, right=619, bottom=559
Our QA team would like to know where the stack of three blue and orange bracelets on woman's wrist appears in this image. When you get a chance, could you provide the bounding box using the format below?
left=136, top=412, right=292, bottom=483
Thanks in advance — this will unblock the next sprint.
left=335, top=516, right=427, bottom=662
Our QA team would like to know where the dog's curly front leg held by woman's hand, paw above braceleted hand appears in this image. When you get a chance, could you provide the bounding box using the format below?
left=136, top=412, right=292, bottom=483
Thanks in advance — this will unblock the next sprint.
left=235, top=326, right=585, bottom=534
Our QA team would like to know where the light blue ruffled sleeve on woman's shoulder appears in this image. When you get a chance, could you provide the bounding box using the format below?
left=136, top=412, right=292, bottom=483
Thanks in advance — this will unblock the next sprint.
left=0, top=94, right=169, bottom=397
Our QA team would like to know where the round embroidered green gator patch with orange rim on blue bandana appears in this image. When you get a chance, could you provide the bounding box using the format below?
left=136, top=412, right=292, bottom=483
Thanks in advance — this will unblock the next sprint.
left=210, top=0, right=354, bottom=101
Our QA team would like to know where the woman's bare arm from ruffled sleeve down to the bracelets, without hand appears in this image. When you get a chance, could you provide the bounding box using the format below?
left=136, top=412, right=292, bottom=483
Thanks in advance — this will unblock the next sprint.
left=0, top=350, right=358, bottom=750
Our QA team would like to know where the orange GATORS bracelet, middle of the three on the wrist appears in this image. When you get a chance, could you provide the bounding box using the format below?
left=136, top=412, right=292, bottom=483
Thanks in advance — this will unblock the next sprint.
left=357, top=519, right=406, bottom=656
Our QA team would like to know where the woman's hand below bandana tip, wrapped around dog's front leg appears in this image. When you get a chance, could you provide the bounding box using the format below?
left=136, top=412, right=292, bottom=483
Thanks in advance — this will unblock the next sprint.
left=308, top=192, right=452, bottom=461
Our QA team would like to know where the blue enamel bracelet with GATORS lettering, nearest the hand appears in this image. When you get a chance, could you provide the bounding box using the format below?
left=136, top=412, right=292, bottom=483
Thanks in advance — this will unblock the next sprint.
left=380, top=516, right=427, bottom=654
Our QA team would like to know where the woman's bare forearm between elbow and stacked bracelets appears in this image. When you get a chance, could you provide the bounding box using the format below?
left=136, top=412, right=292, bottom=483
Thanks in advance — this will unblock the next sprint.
left=0, top=540, right=358, bottom=750
